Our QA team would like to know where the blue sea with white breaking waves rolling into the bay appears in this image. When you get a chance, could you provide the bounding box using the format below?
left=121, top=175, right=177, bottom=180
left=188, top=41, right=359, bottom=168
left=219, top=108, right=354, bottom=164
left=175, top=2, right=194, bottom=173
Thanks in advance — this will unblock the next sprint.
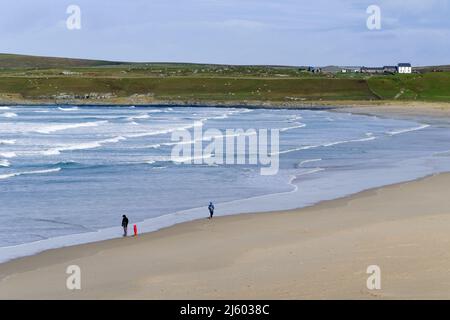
left=0, top=105, right=450, bottom=262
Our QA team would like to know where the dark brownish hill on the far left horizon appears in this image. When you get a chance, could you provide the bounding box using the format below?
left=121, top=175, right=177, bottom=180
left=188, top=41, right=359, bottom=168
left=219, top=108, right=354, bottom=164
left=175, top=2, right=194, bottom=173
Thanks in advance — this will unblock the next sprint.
left=0, top=53, right=126, bottom=69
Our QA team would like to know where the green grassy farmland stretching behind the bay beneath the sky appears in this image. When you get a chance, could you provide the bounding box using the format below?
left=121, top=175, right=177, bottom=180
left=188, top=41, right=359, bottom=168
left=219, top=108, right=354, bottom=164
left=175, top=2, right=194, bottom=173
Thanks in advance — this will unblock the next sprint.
left=0, top=54, right=450, bottom=102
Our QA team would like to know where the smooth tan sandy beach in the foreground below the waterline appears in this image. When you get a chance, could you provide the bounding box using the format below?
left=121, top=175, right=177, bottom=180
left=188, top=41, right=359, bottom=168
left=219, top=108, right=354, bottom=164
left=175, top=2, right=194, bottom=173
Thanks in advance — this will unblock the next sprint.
left=0, top=174, right=450, bottom=299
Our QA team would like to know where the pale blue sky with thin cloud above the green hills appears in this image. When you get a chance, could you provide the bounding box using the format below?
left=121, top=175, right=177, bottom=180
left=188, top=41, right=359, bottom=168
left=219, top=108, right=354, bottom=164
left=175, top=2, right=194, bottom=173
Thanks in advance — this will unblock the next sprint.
left=0, top=0, right=450, bottom=66
